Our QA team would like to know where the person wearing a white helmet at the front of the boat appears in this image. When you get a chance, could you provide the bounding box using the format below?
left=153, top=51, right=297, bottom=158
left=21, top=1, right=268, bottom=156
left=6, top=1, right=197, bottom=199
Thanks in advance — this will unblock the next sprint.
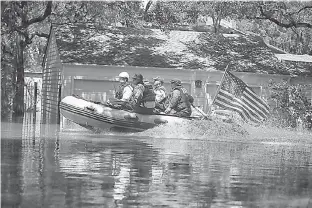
left=115, top=72, right=133, bottom=101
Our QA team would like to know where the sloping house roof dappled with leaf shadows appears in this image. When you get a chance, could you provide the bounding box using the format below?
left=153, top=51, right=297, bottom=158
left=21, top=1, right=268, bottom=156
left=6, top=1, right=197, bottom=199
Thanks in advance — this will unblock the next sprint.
left=55, top=24, right=310, bottom=74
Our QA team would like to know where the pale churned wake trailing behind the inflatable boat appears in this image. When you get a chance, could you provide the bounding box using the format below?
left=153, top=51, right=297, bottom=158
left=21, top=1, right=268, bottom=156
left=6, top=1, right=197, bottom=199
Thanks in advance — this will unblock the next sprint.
left=135, top=120, right=312, bottom=146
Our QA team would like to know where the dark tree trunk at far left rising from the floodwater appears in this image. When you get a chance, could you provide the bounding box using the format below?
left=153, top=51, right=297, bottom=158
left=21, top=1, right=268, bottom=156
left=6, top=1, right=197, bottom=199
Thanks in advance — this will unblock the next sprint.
left=13, top=35, right=25, bottom=116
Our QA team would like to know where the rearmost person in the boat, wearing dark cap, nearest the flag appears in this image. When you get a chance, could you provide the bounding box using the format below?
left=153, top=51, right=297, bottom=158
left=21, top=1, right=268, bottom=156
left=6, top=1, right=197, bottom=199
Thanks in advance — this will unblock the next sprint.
left=165, top=79, right=192, bottom=117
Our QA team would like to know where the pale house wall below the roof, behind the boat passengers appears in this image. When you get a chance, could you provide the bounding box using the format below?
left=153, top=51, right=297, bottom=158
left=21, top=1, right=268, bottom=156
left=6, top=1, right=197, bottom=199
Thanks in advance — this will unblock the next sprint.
left=63, top=64, right=305, bottom=111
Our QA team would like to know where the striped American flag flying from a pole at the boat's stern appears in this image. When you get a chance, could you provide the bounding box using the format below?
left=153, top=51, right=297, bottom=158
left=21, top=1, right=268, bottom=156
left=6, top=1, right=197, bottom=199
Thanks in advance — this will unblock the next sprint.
left=214, top=71, right=270, bottom=123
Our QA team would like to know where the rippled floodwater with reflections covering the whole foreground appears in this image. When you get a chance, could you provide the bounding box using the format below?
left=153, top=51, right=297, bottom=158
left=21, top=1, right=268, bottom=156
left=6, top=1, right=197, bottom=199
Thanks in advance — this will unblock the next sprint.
left=1, top=114, right=312, bottom=208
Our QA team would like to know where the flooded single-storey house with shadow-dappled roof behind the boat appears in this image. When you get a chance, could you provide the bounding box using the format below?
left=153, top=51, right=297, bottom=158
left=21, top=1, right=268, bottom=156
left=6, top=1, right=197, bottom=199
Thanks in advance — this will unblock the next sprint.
left=42, top=24, right=310, bottom=123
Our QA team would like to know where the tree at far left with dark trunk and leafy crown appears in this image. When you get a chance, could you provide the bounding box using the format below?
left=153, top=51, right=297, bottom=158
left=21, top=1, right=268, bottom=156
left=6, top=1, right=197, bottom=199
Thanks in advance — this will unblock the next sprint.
left=1, top=1, right=52, bottom=116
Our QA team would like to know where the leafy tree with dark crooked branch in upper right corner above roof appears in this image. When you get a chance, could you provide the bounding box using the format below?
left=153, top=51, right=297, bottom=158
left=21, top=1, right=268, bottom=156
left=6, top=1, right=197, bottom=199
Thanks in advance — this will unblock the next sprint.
left=237, top=1, right=312, bottom=55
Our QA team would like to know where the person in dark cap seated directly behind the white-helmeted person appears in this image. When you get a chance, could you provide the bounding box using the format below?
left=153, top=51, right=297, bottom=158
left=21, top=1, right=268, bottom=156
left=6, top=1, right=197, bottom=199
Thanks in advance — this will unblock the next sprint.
left=130, top=74, right=145, bottom=108
